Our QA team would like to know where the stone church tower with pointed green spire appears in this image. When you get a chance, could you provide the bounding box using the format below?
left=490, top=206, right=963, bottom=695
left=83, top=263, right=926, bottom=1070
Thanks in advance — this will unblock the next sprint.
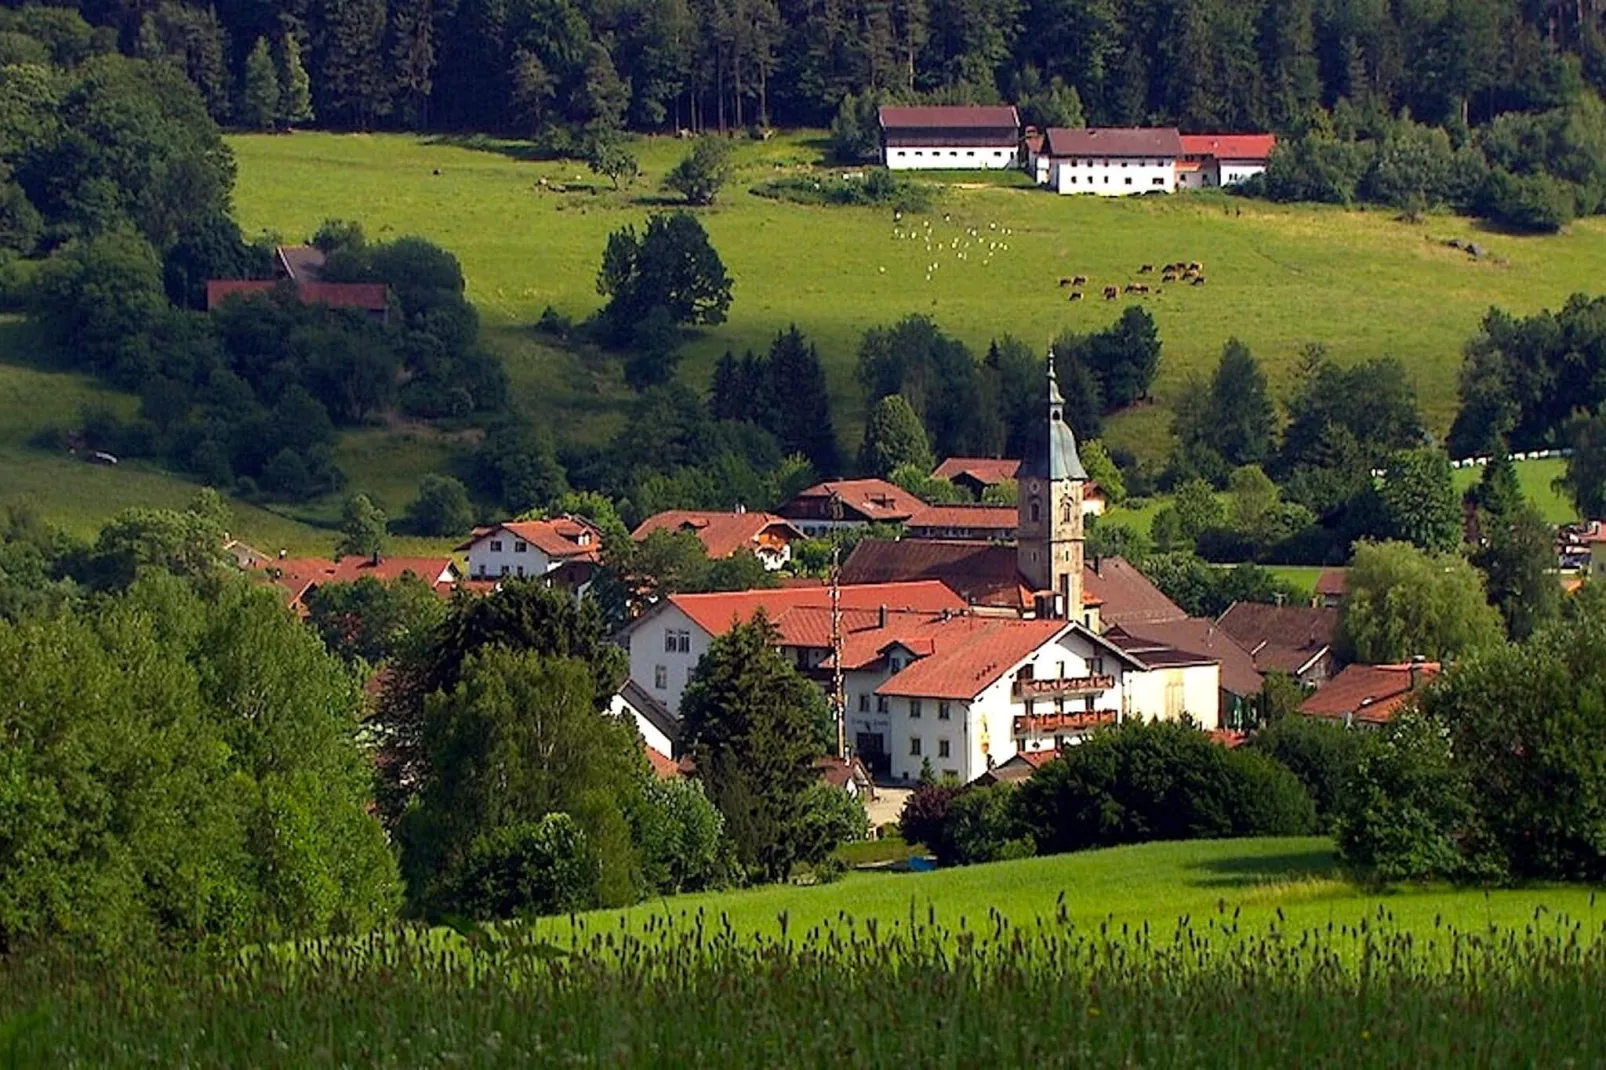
left=1015, top=350, right=1087, bottom=620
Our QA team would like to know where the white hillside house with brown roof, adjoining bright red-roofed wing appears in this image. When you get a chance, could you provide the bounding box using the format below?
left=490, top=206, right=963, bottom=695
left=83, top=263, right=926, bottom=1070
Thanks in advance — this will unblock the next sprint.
left=1042, top=127, right=1182, bottom=198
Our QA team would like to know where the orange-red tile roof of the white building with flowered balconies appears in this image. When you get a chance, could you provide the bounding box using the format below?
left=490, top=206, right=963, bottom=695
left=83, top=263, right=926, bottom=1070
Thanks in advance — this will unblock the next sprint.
left=875, top=614, right=1074, bottom=700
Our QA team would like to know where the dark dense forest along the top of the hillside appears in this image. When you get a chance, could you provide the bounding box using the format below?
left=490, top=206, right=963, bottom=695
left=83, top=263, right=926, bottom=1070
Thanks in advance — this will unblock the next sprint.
left=18, top=0, right=1606, bottom=138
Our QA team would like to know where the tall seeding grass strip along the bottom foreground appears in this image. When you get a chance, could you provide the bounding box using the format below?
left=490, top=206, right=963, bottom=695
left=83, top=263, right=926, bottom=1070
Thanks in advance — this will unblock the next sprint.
left=12, top=903, right=1606, bottom=1067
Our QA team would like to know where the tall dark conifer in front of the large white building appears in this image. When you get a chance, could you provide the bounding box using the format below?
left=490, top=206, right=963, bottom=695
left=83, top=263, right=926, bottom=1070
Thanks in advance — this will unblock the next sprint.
left=681, top=615, right=830, bottom=880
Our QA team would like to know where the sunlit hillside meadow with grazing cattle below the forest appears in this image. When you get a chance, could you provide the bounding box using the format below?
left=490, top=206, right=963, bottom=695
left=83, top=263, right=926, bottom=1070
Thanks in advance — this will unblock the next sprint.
left=230, top=126, right=1606, bottom=465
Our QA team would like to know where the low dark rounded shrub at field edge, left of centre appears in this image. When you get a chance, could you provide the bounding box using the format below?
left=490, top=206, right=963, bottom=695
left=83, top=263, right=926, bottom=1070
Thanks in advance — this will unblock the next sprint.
left=454, top=813, right=599, bottom=919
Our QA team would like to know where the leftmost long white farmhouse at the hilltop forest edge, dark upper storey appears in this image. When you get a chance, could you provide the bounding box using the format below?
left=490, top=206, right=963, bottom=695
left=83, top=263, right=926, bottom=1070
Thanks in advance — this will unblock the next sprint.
left=880, top=104, right=1020, bottom=170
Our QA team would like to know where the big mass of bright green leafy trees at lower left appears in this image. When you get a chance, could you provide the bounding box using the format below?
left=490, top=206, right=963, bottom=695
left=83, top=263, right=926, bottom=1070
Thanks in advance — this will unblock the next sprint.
left=0, top=572, right=398, bottom=948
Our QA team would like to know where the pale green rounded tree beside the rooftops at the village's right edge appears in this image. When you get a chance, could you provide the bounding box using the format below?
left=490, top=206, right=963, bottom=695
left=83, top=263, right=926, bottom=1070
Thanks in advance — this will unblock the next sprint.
left=1339, top=543, right=1500, bottom=664
